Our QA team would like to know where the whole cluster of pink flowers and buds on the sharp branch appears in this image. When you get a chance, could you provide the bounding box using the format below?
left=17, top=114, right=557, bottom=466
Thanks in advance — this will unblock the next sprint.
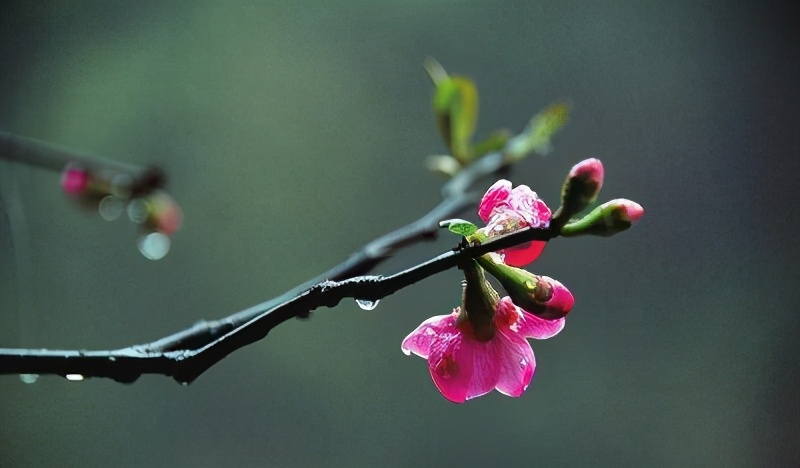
left=402, top=159, right=643, bottom=403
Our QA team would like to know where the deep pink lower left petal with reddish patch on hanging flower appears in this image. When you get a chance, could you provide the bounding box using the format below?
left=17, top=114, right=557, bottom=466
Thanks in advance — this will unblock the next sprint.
left=428, top=329, right=475, bottom=403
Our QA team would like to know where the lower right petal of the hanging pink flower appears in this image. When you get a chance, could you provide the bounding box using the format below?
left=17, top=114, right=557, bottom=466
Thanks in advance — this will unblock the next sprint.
left=495, top=330, right=536, bottom=397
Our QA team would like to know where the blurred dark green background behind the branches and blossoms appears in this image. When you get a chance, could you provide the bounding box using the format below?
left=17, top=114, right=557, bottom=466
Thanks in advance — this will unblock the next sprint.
left=0, top=0, right=800, bottom=468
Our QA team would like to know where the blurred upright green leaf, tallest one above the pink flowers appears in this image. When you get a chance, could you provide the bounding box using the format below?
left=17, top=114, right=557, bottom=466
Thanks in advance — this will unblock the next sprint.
left=433, top=76, right=478, bottom=164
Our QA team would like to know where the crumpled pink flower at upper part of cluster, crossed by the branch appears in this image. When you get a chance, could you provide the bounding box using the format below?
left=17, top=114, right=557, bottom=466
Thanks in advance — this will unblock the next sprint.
left=478, top=179, right=551, bottom=267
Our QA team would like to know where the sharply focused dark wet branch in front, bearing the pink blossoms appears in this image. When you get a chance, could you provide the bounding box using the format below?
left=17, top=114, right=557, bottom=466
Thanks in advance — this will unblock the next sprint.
left=0, top=228, right=556, bottom=383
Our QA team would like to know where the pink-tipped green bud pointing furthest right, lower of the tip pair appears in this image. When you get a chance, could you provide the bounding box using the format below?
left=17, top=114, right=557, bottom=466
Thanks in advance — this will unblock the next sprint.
left=561, top=198, right=644, bottom=237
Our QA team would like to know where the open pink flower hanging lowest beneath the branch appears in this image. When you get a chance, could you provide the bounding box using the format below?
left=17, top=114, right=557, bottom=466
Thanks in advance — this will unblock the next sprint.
left=402, top=297, right=564, bottom=403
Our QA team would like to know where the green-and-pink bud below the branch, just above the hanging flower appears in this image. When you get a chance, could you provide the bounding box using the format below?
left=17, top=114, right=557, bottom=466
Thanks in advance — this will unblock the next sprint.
left=478, top=255, right=575, bottom=320
